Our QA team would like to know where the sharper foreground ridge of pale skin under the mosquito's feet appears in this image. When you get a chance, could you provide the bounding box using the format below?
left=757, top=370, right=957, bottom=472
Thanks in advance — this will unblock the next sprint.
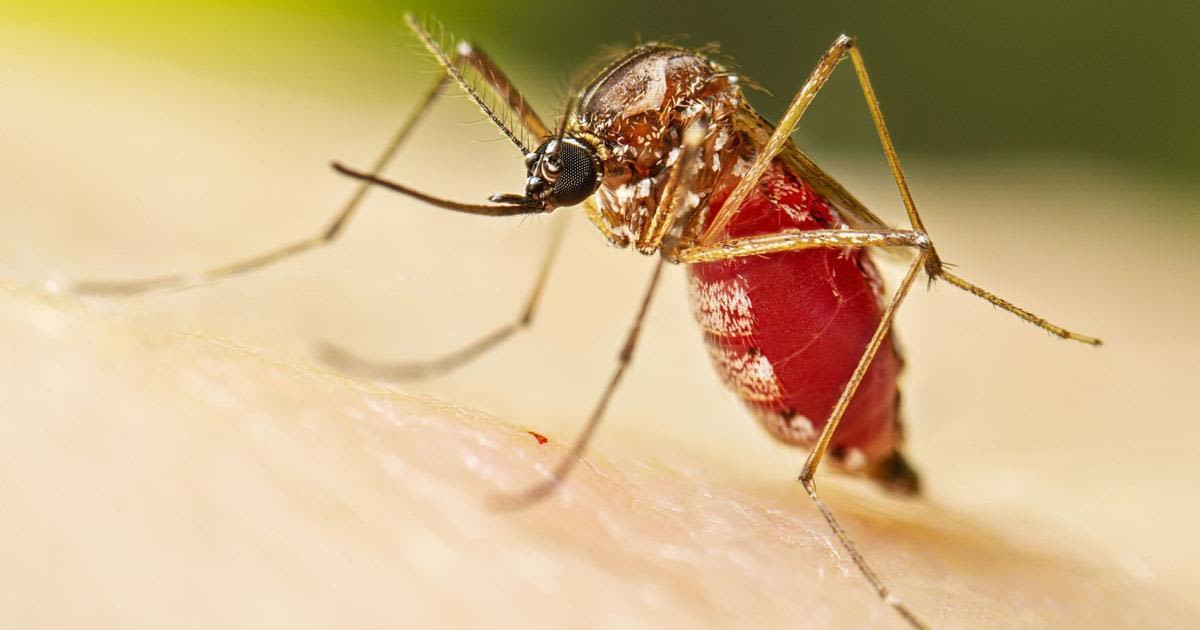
left=0, top=279, right=1177, bottom=628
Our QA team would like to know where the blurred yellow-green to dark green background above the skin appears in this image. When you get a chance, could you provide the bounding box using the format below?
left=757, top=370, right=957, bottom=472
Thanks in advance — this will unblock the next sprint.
left=0, top=0, right=1200, bottom=187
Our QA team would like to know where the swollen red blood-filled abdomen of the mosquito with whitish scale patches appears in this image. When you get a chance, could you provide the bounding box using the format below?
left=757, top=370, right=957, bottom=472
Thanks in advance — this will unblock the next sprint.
left=689, top=162, right=902, bottom=469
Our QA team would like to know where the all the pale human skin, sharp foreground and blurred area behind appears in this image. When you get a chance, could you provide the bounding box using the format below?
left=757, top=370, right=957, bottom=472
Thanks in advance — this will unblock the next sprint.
left=0, top=22, right=1200, bottom=628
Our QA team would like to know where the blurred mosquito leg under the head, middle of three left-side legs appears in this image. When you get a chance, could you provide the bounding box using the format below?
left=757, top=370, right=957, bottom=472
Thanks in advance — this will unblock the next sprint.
left=320, top=215, right=568, bottom=380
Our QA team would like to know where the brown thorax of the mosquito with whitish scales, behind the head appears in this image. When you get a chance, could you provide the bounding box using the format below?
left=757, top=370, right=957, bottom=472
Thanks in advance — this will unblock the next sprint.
left=569, top=43, right=755, bottom=254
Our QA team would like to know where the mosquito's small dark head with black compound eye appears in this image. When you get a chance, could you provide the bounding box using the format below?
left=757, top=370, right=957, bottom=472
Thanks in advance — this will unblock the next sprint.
left=492, top=136, right=604, bottom=211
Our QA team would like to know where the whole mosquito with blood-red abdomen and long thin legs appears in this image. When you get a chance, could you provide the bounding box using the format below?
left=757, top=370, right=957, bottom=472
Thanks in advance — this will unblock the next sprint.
left=74, top=14, right=1100, bottom=628
